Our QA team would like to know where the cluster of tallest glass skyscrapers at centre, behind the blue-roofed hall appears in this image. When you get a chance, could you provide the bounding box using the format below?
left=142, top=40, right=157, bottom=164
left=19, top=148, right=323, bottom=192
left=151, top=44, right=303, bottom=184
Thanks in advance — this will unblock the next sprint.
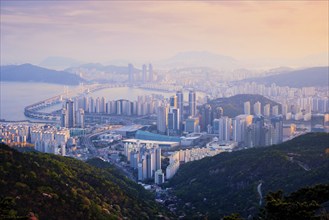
left=157, top=91, right=196, bottom=135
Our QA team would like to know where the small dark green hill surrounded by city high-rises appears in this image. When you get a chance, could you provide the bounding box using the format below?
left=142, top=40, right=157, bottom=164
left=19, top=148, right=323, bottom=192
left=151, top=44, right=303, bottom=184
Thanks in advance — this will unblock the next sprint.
left=209, top=94, right=281, bottom=118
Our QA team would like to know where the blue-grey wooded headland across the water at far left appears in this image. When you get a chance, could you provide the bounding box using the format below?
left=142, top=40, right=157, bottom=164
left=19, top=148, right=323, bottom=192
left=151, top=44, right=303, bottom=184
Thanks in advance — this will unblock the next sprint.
left=0, top=64, right=85, bottom=85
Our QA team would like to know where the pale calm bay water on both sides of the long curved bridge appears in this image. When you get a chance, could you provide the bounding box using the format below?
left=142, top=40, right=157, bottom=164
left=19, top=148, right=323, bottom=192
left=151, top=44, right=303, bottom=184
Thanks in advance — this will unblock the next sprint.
left=0, top=81, right=179, bottom=121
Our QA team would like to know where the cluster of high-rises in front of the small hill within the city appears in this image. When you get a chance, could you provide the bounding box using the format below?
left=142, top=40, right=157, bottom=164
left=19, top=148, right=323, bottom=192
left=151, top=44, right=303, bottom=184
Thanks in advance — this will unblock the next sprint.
left=195, top=101, right=283, bottom=147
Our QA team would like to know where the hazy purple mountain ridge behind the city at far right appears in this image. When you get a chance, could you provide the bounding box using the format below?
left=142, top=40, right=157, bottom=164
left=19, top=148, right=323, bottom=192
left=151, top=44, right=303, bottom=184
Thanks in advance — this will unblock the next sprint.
left=246, top=66, right=329, bottom=88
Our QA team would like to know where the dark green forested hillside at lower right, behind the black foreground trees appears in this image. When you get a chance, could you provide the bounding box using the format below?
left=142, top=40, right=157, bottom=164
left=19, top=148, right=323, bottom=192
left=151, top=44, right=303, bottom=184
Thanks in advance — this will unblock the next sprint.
left=168, top=133, right=329, bottom=219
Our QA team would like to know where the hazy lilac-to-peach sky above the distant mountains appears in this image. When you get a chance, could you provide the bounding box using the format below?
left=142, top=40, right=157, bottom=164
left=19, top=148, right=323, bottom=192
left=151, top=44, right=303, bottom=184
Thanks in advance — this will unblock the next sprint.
left=1, top=0, right=329, bottom=64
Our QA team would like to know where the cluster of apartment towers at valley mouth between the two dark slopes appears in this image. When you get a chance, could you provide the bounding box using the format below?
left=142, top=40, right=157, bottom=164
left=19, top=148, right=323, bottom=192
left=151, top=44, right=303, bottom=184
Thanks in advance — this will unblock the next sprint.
left=124, top=142, right=164, bottom=184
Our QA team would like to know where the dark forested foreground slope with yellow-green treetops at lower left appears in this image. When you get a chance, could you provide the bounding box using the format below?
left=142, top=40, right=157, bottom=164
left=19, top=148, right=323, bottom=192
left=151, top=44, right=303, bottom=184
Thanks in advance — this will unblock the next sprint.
left=0, top=145, right=166, bottom=219
